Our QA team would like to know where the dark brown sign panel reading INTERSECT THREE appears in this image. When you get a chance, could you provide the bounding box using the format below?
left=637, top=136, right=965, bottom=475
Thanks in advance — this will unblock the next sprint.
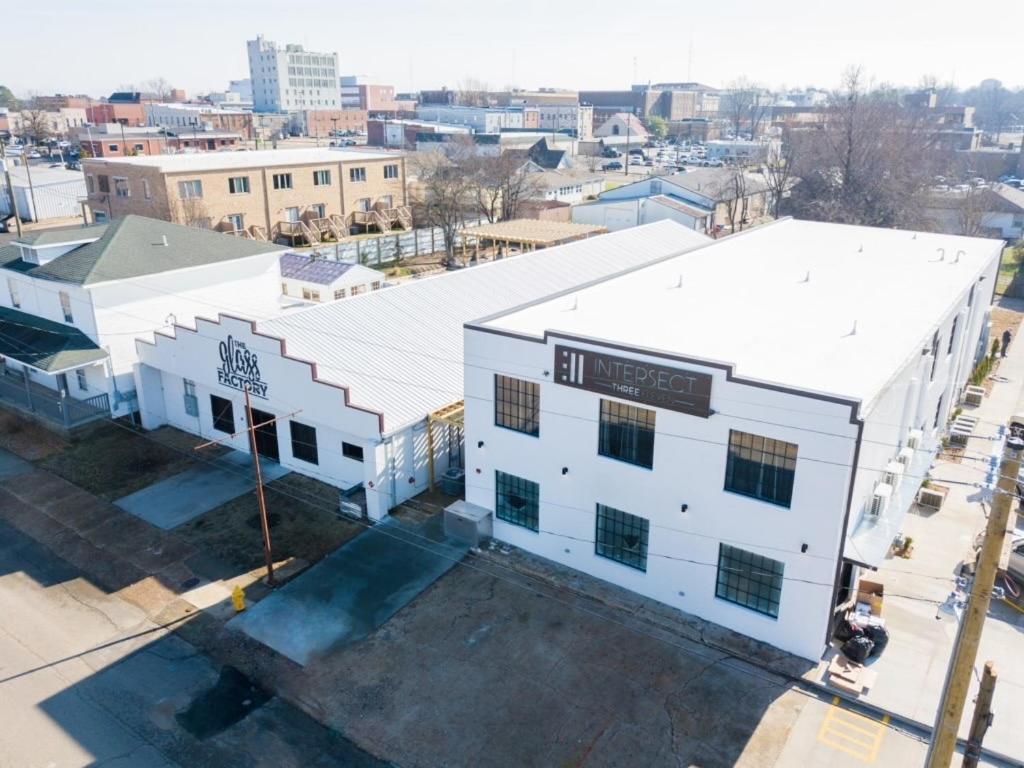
left=555, top=344, right=711, bottom=419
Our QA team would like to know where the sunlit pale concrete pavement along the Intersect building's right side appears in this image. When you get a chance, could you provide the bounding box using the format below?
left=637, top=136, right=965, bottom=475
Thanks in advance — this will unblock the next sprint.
left=813, top=302, right=1024, bottom=760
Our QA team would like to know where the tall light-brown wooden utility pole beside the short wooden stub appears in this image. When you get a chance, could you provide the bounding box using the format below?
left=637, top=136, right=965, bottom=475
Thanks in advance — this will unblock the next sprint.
left=926, top=432, right=1024, bottom=768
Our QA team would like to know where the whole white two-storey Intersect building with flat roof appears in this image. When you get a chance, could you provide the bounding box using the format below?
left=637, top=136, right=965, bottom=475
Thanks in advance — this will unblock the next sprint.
left=465, top=220, right=1001, bottom=659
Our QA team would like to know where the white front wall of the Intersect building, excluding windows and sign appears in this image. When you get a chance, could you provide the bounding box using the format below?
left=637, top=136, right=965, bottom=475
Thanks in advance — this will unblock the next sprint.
left=465, top=329, right=857, bottom=658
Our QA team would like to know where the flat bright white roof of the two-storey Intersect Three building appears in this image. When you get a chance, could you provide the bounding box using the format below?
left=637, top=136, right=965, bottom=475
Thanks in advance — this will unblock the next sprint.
left=477, top=219, right=1002, bottom=407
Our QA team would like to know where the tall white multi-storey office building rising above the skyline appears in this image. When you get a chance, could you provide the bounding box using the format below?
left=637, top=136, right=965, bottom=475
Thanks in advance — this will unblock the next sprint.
left=247, top=35, right=341, bottom=112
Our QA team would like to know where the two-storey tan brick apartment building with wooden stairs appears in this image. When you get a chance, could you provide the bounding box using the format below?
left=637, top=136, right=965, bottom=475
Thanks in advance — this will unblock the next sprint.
left=83, top=148, right=412, bottom=245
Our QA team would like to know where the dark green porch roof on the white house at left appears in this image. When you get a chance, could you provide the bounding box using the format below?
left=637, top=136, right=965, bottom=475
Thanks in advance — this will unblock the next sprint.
left=0, top=307, right=108, bottom=374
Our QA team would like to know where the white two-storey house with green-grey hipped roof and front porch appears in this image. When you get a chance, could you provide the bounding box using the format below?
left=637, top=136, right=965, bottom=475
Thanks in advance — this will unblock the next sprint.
left=0, top=216, right=288, bottom=426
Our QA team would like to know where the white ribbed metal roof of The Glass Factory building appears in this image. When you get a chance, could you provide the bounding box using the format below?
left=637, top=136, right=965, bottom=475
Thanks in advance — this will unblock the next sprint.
left=258, top=221, right=709, bottom=432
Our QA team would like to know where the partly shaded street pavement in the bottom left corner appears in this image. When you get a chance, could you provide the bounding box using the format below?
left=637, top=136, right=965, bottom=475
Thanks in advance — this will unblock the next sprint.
left=0, top=523, right=384, bottom=768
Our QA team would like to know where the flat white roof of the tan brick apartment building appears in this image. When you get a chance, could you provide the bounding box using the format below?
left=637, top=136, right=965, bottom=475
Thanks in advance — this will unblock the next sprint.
left=88, top=146, right=401, bottom=173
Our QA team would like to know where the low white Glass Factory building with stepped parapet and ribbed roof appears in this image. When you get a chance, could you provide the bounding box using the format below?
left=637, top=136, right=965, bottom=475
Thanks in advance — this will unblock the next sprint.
left=136, top=222, right=707, bottom=520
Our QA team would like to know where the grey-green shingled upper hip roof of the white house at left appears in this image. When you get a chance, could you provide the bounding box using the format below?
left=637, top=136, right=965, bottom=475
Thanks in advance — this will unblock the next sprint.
left=22, top=216, right=282, bottom=286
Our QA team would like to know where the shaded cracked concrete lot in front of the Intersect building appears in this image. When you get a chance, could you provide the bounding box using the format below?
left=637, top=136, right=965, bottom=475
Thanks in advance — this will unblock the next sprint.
left=270, top=558, right=807, bottom=767
